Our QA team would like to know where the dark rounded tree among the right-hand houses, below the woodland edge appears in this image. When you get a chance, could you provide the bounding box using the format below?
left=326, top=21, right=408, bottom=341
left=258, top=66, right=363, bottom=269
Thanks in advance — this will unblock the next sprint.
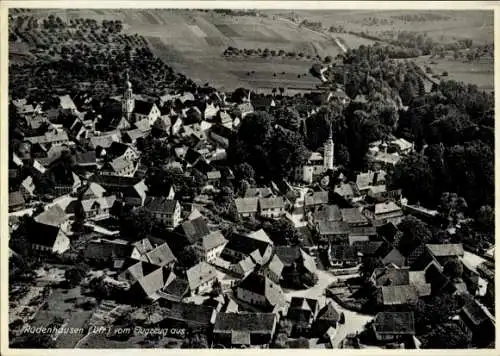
left=398, top=215, right=432, bottom=256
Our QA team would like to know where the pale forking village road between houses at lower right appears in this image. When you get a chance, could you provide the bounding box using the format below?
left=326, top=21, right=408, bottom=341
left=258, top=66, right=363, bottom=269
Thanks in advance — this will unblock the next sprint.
left=285, top=270, right=373, bottom=348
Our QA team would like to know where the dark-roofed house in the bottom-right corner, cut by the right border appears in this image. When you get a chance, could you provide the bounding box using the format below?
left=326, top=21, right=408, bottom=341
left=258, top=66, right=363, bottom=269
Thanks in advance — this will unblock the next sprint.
left=458, top=298, right=495, bottom=348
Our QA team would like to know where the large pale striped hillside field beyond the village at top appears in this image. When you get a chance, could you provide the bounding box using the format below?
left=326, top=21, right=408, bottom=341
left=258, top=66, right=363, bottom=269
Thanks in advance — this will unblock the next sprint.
left=10, top=9, right=341, bottom=92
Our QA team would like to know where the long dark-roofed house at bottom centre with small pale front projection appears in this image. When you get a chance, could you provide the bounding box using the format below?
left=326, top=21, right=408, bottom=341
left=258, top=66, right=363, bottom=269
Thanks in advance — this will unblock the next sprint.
left=213, top=312, right=277, bottom=347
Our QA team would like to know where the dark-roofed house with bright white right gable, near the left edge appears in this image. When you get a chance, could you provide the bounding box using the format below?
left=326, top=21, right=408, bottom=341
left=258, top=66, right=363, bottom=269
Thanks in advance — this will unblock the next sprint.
left=28, top=222, right=71, bottom=254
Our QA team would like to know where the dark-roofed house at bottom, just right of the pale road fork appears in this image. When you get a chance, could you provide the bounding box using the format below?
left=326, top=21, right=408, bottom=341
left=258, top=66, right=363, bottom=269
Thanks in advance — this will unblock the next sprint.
left=373, top=312, right=415, bottom=342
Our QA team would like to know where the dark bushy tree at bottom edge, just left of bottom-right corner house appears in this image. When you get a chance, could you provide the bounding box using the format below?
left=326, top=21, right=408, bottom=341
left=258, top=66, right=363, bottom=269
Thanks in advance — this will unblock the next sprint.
left=422, top=322, right=471, bottom=349
